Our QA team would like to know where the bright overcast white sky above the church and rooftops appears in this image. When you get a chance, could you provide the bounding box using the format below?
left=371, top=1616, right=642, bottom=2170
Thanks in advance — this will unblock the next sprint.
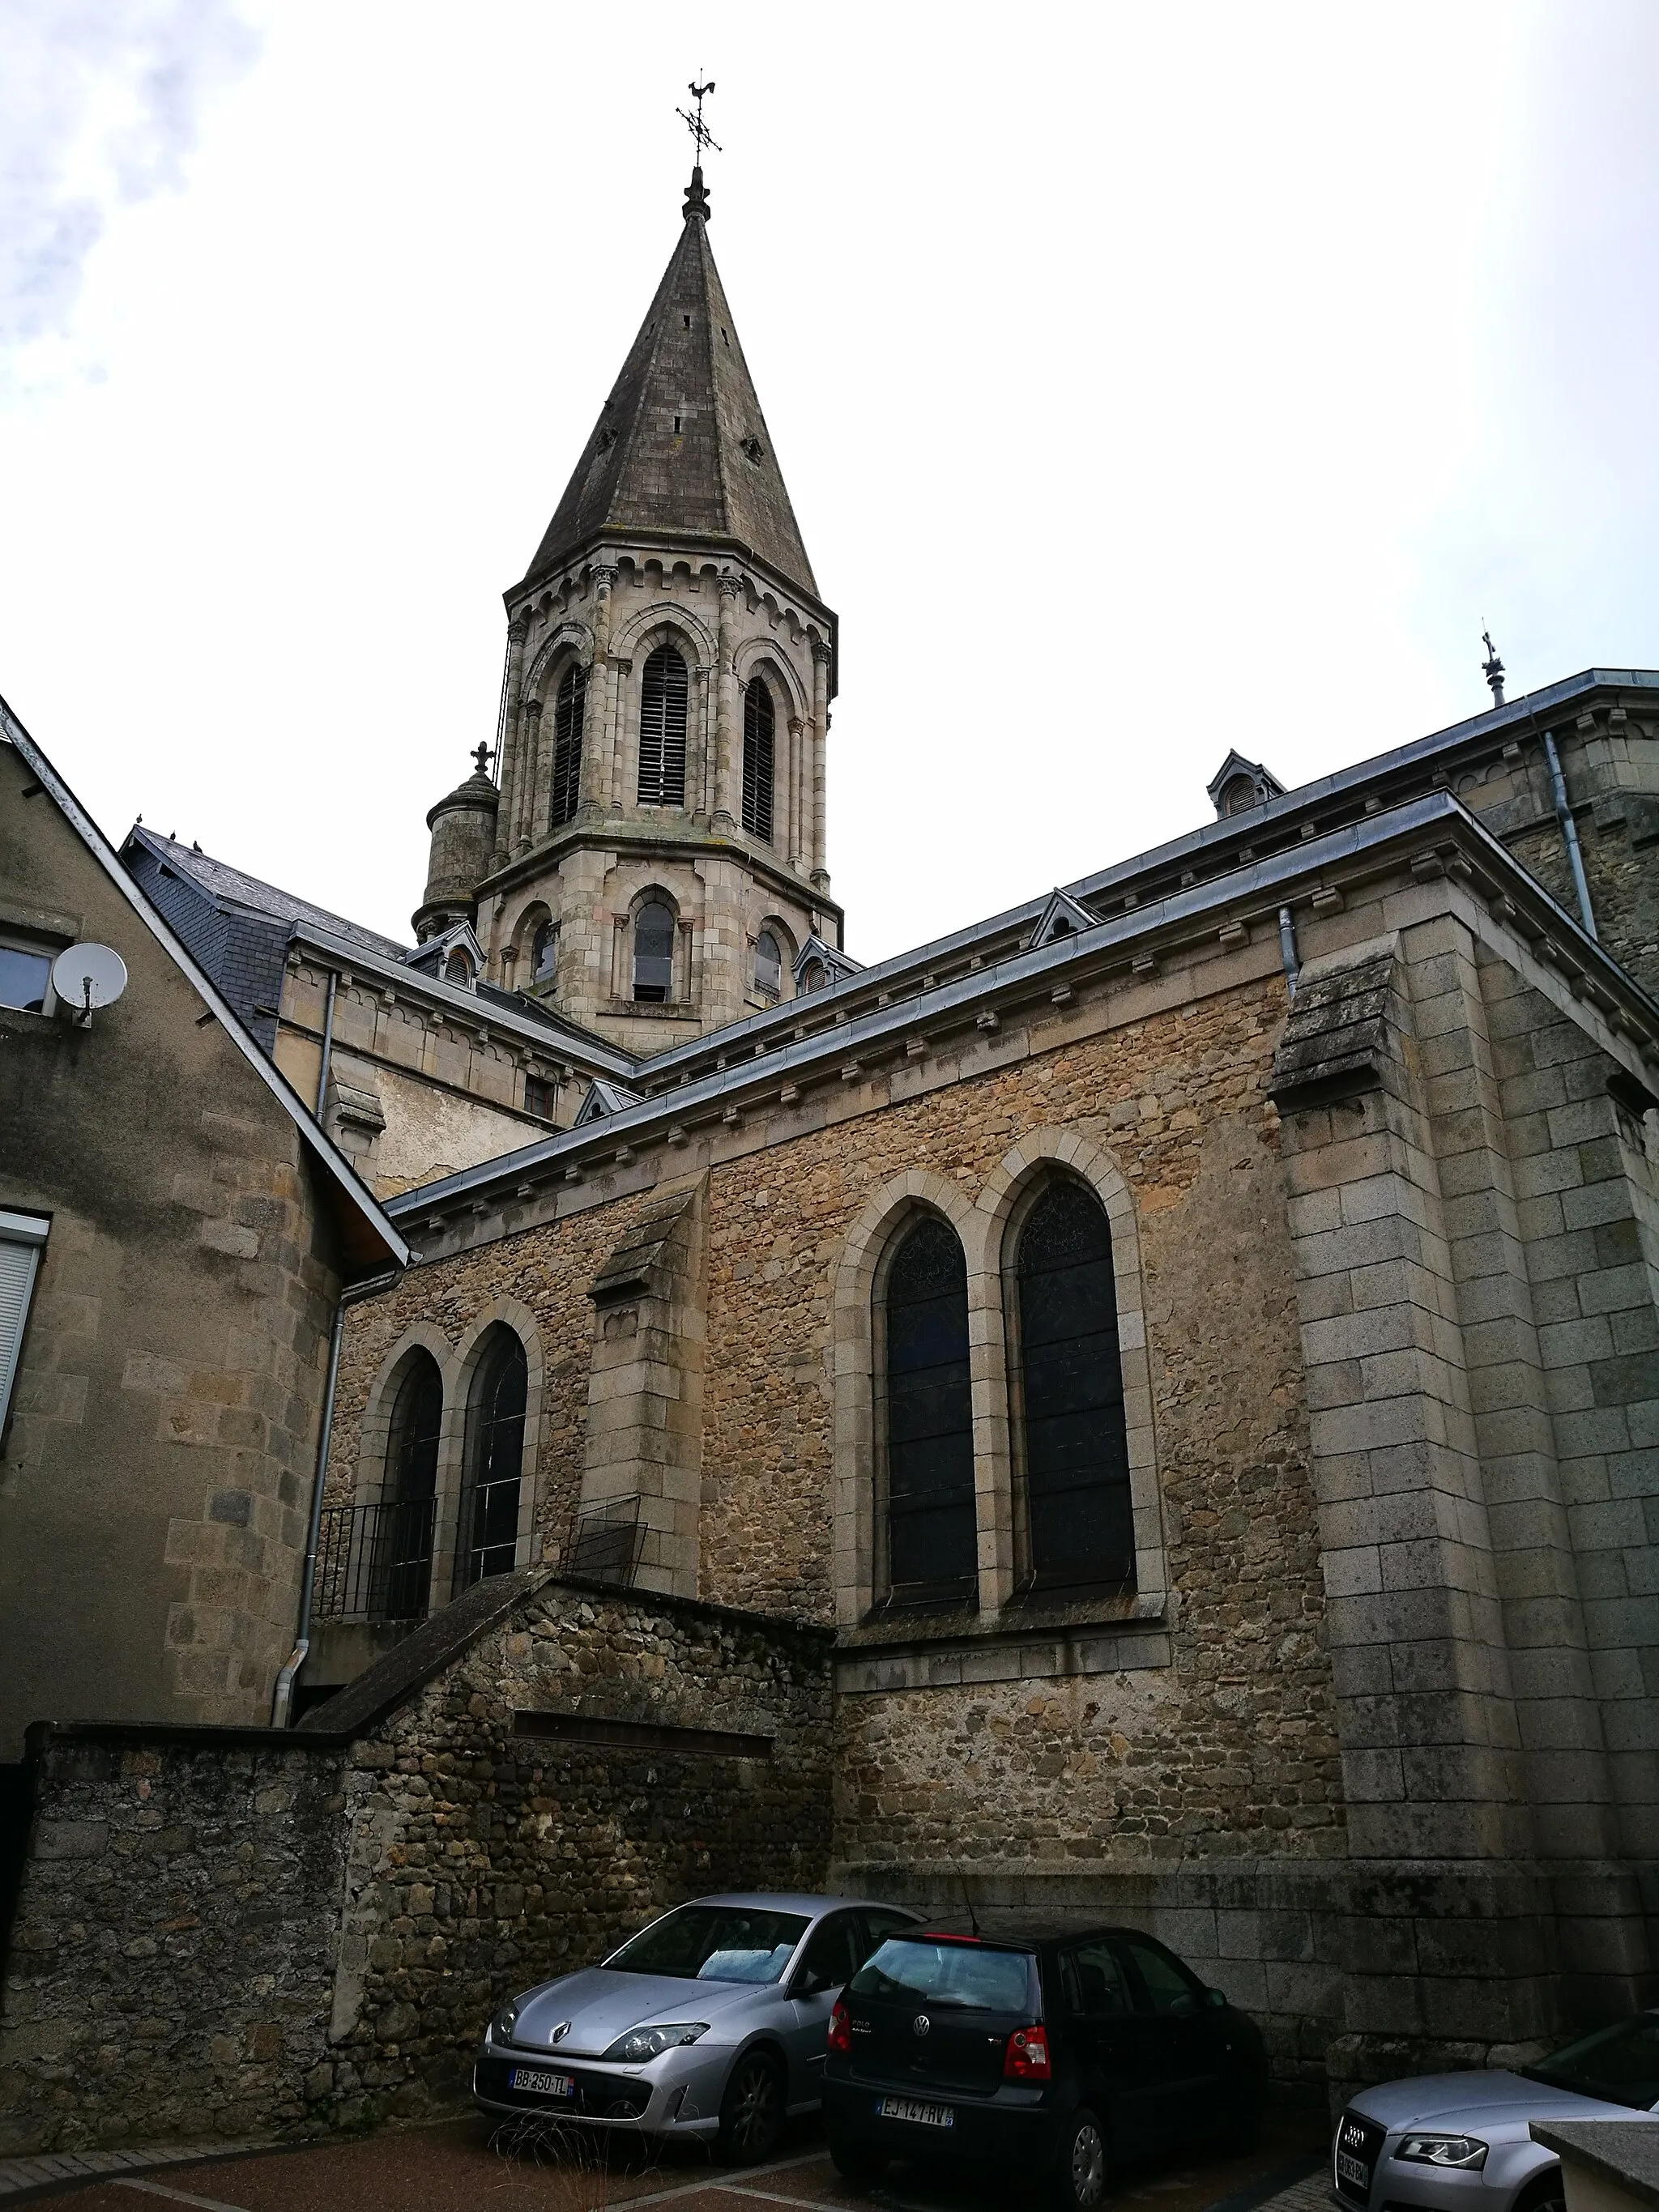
left=0, top=0, right=1659, bottom=958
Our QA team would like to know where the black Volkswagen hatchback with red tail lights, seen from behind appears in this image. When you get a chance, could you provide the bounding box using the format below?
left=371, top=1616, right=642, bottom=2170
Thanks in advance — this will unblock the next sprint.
left=823, top=1927, right=1268, bottom=2212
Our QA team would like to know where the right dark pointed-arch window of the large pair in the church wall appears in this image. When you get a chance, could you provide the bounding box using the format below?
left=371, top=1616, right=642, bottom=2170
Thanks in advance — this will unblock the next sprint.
left=1009, top=1177, right=1135, bottom=1588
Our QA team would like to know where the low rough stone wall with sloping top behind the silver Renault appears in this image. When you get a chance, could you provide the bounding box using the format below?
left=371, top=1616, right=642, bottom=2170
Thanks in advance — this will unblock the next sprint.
left=0, top=1583, right=830, bottom=2152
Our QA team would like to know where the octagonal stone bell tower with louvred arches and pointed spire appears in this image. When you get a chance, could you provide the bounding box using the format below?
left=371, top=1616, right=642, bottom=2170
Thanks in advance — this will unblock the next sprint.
left=418, top=168, right=841, bottom=1053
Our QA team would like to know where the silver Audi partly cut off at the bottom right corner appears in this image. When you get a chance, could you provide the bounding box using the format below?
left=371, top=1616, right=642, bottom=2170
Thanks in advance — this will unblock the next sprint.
left=1332, top=2010, right=1659, bottom=2212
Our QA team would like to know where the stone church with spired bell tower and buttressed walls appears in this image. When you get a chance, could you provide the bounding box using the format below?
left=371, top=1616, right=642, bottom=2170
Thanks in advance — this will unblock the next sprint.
left=0, top=170, right=1659, bottom=2141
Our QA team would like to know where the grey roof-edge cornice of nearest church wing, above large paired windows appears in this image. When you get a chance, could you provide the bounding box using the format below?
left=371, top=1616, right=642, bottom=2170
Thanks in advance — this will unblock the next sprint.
left=390, top=792, right=1659, bottom=1241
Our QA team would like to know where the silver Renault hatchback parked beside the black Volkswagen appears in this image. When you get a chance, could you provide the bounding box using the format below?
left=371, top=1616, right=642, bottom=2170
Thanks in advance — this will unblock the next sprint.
left=473, top=1891, right=915, bottom=2166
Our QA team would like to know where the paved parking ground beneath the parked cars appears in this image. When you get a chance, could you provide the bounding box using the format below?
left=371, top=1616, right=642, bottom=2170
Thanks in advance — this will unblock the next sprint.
left=6, top=2115, right=1325, bottom=2212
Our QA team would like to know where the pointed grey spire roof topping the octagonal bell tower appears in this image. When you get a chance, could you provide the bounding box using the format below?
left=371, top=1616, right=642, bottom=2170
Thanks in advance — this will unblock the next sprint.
left=524, top=170, right=818, bottom=599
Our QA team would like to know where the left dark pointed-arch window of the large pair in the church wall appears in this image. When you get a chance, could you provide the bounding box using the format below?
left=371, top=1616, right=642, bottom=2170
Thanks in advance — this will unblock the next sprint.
left=883, top=1214, right=978, bottom=1606
